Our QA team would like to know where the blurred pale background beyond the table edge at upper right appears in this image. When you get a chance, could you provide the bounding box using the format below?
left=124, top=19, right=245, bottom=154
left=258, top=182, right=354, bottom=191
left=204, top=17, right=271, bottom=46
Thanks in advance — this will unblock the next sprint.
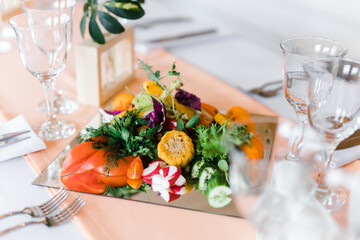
left=151, top=0, right=360, bottom=59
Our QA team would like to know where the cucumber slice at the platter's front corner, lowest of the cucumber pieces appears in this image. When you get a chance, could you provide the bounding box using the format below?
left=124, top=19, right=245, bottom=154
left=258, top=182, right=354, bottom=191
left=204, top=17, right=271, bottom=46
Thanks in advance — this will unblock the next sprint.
left=206, top=174, right=232, bottom=208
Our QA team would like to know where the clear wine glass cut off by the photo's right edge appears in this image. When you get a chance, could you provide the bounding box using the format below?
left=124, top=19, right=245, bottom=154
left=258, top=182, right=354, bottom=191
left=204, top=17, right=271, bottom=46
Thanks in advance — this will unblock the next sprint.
left=304, top=59, right=360, bottom=212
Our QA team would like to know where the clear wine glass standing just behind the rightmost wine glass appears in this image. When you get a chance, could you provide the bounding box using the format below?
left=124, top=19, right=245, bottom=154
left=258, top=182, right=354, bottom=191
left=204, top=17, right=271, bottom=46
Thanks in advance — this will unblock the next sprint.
left=276, top=37, right=348, bottom=160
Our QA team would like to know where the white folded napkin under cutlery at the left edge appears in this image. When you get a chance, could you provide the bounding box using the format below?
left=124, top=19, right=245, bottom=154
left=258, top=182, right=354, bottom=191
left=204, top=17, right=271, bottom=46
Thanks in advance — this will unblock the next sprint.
left=0, top=115, right=46, bottom=162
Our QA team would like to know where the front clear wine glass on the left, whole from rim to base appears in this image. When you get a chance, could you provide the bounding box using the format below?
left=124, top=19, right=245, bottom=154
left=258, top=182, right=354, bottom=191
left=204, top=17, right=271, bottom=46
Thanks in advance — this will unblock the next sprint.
left=9, top=11, right=76, bottom=140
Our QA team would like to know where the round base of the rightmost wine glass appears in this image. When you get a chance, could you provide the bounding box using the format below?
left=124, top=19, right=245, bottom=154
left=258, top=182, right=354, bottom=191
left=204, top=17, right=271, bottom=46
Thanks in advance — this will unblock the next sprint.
left=315, top=186, right=347, bottom=212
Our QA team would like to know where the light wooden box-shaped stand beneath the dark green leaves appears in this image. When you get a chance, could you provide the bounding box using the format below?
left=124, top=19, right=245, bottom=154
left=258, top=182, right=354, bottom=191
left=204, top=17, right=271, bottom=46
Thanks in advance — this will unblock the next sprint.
left=75, top=27, right=135, bottom=107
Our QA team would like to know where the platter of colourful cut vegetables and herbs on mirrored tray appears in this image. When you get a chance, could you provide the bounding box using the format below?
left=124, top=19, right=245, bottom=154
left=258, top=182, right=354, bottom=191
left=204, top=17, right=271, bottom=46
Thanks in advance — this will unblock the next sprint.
left=34, top=61, right=276, bottom=215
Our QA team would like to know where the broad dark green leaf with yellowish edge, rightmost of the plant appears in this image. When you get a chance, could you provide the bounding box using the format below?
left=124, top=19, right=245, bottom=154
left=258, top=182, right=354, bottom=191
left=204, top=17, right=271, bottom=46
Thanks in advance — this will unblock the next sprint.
left=104, top=1, right=145, bottom=19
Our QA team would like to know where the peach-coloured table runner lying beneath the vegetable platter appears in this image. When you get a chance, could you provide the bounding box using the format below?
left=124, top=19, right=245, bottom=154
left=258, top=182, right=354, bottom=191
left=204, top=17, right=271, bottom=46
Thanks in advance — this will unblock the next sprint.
left=0, top=4, right=360, bottom=240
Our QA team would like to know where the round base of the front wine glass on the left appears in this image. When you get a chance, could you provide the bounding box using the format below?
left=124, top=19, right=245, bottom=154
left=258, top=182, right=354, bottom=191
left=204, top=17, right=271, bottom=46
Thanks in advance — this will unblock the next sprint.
left=34, top=120, right=76, bottom=141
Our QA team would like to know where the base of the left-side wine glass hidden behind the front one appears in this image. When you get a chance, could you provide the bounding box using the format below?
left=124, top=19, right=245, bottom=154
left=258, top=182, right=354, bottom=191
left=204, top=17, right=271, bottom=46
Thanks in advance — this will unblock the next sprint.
left=38, top=90, right=80, bottom=114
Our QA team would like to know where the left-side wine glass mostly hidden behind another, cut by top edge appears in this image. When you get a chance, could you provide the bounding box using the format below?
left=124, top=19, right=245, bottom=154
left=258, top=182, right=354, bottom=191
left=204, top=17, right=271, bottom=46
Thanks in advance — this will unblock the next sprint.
left=20, top=0, right=79, bottom=114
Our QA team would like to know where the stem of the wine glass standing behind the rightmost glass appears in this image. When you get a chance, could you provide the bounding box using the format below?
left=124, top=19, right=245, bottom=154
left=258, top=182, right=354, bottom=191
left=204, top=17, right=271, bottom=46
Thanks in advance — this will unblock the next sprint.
left=286, top=113, right=308, bottom=160
